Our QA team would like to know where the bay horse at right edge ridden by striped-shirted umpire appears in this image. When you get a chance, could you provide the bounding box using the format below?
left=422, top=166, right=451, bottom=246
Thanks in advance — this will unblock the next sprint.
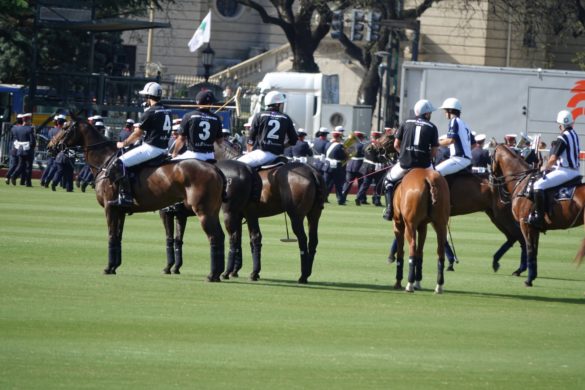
left=492, top=144, right=585, bottom=287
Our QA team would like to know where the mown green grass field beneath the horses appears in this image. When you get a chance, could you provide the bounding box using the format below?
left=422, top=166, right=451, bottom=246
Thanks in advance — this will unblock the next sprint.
left=0, top=181, right=585, bottom=390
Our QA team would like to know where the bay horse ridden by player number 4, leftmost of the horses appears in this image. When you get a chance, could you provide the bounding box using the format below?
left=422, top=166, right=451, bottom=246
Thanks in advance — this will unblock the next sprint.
left=49, top=121, right=225, bottom=282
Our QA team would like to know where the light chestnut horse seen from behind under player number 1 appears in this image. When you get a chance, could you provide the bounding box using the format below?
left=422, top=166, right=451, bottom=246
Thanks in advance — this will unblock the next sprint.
left=393, top=168, right=450, bottom=294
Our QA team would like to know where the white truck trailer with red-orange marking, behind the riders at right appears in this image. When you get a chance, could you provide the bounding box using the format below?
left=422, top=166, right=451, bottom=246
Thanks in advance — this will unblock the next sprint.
left=399, top=61, right=585, bottom=148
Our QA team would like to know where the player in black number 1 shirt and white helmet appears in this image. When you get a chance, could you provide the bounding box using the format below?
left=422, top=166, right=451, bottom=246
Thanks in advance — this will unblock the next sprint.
left=382, top=99, right=439, bottom=221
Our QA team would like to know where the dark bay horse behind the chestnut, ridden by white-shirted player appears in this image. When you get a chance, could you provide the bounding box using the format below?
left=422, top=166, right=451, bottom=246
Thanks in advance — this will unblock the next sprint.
left=379, top=135, right=526, bottom=274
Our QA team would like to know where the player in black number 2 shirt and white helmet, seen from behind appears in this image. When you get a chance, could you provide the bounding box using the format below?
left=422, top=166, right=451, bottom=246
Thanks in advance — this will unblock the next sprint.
left=238, top=91, right=298, bottom=167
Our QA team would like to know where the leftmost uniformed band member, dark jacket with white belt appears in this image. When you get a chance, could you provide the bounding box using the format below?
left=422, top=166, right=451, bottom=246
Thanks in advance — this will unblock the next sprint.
left=6, top=113, right=36, bottom=187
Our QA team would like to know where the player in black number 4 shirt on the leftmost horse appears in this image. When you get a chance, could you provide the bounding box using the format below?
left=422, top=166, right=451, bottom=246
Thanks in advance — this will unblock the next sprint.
left=109, top=82, right=173, bottom=207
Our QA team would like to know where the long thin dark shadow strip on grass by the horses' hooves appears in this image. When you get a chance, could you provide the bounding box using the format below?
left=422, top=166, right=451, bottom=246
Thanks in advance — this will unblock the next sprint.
left=228, top=278, right=585, bottom=305
